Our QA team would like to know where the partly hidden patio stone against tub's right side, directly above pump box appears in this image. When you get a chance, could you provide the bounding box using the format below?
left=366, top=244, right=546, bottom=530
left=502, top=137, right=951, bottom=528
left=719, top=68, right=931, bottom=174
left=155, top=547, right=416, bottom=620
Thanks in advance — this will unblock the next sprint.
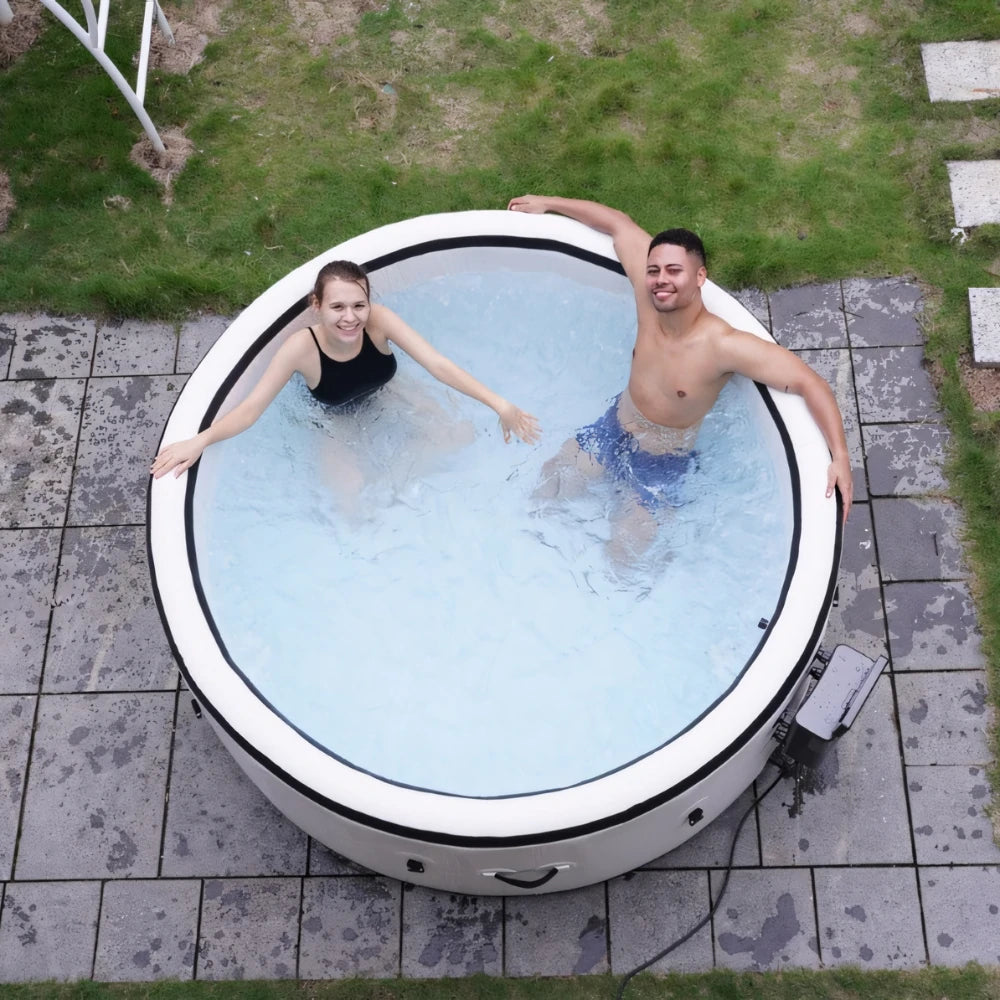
left=823, top=503, right=886, bottom=659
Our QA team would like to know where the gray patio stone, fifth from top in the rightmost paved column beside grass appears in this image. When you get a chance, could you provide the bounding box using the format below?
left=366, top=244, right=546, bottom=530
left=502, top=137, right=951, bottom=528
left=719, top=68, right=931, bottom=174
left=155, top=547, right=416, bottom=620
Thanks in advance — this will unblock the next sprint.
left=885, top=582, right=986, bottom=670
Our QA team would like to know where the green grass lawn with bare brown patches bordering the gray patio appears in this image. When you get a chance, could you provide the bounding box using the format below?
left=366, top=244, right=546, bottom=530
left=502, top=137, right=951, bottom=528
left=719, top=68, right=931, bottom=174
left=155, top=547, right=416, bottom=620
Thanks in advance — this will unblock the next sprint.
left=0, top=0, right=1000, bottom=1000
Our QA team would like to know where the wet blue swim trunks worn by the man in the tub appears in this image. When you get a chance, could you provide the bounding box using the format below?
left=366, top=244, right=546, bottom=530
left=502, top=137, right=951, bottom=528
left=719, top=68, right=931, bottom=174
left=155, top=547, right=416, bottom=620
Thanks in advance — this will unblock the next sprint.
left=576, top=396, right=697, bottom=511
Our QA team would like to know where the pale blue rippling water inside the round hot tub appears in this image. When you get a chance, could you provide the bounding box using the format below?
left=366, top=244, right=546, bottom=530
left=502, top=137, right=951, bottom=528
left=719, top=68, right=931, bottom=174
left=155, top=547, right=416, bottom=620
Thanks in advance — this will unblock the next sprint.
left=196, top=272, right=791, bottom=796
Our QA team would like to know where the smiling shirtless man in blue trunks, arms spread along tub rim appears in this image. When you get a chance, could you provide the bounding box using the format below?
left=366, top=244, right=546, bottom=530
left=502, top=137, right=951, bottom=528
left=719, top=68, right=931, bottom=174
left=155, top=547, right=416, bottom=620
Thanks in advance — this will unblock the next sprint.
left=508, top=195, right=853, bottom=549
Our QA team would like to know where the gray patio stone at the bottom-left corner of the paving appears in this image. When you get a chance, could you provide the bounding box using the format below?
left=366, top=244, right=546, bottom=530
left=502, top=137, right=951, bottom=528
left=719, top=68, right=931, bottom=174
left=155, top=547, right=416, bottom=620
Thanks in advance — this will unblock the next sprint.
left=0, top=882, right=101, bottom=983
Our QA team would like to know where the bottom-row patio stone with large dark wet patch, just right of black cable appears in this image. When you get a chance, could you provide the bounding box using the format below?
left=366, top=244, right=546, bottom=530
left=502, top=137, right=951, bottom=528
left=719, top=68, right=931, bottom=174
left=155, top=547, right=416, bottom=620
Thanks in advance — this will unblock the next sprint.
left=711, top=868, right=820, bottom=971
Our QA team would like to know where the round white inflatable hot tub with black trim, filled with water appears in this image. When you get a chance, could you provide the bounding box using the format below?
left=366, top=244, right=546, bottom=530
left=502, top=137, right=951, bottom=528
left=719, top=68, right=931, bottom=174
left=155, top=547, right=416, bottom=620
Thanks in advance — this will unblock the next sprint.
left=148, top=212, right=840, bottom=894
